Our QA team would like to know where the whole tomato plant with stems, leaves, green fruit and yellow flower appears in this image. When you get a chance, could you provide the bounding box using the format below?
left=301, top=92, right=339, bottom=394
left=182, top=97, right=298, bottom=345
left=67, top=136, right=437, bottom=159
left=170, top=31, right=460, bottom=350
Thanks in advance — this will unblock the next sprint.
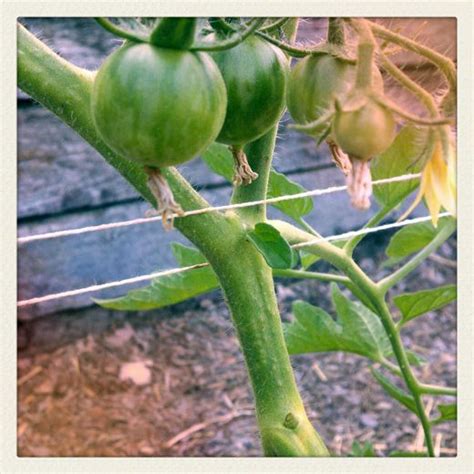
left=18, top=18, right=457, bottom=456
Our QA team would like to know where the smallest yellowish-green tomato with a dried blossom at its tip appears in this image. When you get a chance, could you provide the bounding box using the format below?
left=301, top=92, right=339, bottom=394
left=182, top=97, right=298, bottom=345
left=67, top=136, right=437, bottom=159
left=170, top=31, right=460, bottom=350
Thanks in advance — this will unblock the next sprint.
left=332, top=98, right=396, bottom=160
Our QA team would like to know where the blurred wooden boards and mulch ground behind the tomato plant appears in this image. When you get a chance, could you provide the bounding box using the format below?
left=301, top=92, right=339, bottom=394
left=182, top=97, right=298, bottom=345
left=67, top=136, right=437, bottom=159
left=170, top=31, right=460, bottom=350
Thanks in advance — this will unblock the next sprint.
left=18, top=18, right=456, bottom=456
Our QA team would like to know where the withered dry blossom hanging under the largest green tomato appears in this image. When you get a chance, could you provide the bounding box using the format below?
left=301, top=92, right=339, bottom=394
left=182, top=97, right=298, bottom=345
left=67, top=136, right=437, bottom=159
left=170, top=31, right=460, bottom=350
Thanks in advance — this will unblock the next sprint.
left=144, top=166, right=184, bottom=230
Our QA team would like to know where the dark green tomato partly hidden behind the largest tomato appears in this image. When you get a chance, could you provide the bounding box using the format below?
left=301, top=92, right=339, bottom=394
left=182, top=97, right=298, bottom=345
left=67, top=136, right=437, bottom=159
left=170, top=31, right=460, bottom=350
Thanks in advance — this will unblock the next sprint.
left=212, top=36, right=289, bottom=145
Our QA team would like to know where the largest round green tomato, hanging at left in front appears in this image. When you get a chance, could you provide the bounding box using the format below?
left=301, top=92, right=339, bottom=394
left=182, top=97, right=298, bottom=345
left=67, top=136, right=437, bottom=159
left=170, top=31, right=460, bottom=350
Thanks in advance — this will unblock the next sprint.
left=92, top=43, right=226, bottom=167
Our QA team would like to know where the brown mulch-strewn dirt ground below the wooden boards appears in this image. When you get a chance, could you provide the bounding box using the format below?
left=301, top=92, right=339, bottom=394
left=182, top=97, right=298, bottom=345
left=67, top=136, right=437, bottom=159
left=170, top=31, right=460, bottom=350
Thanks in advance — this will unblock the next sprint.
left=18, top=234, right=456, bottom=456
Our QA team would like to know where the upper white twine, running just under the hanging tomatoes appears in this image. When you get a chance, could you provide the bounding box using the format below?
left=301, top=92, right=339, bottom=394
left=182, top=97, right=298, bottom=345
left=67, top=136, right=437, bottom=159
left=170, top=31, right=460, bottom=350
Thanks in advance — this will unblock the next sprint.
left=17, top=173, right=421, bottom=244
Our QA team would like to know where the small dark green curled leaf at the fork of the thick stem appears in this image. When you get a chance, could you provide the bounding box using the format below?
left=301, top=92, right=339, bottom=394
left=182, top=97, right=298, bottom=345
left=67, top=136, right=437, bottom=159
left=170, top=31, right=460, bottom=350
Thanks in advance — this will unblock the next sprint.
left=247, top=222, right=298, bottom=269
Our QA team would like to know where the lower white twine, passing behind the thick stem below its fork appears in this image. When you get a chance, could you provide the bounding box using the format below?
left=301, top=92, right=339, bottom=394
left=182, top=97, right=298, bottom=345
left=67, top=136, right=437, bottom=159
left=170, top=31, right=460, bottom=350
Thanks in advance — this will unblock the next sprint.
left=17, top=212, right=451, bottom=307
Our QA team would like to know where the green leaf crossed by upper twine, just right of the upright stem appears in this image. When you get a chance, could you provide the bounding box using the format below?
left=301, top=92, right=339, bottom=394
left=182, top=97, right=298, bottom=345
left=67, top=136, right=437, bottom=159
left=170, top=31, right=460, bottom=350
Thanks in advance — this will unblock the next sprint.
left=267, top=170, right=313, bottom=219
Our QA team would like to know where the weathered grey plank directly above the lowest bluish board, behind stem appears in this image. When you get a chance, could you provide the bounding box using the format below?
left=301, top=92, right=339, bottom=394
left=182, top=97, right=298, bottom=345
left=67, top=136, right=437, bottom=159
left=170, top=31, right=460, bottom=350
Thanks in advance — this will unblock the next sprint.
left=18, top=107, right=328, bottom=219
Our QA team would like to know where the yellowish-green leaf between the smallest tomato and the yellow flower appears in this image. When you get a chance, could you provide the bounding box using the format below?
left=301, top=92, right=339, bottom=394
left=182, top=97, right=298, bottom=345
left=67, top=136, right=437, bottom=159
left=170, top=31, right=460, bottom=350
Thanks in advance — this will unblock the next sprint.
left=371, top=125, right=428, bottom=207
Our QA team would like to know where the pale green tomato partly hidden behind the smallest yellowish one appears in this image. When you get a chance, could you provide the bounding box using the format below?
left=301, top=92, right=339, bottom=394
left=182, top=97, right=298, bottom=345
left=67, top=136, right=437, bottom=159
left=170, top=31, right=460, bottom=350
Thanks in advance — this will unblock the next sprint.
left=286, top=54, right=383, bottom=132
